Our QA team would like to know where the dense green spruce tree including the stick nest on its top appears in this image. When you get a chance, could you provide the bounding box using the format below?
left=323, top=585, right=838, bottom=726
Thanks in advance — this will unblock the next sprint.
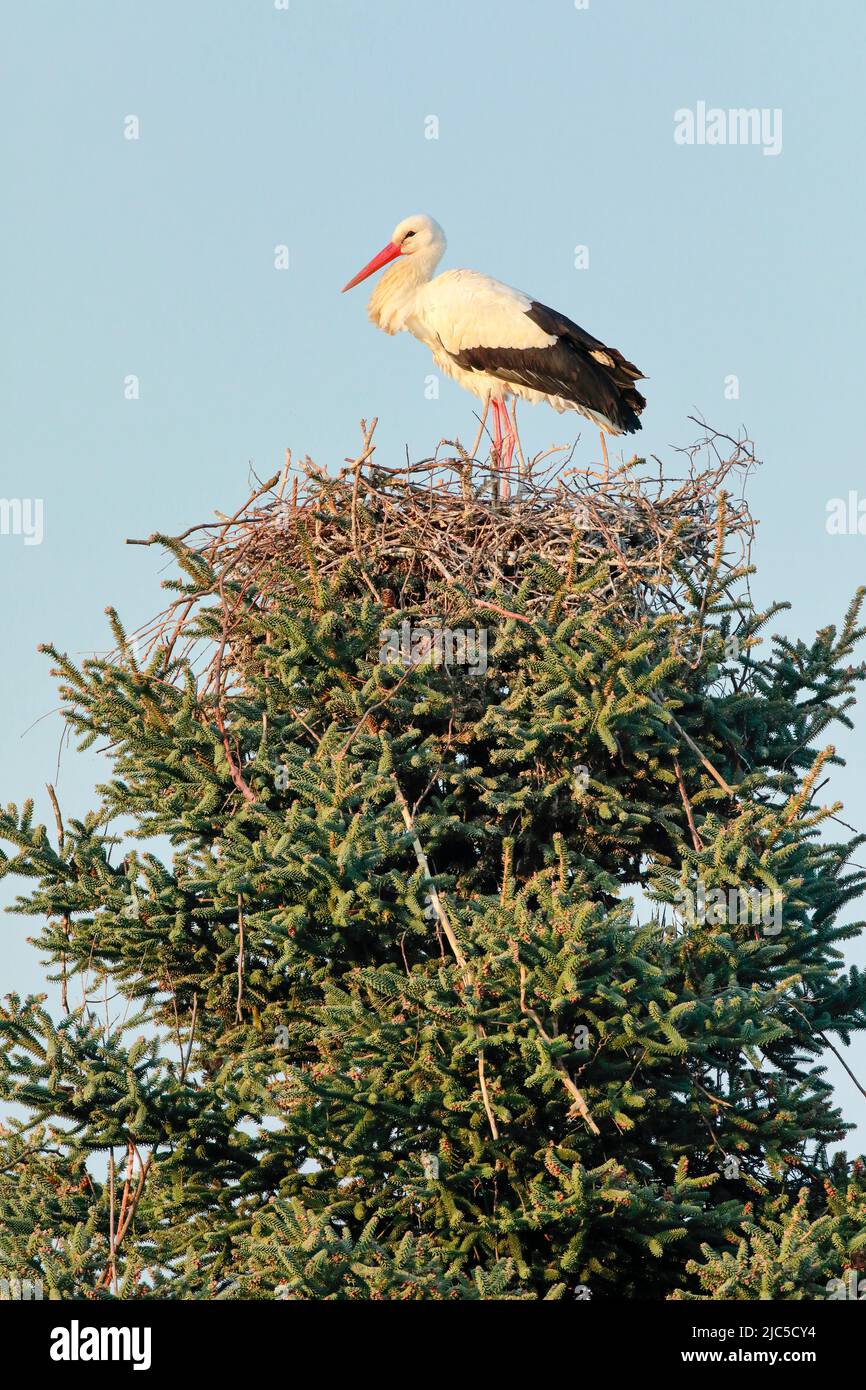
left=0, top=432, right=866, bottom=1300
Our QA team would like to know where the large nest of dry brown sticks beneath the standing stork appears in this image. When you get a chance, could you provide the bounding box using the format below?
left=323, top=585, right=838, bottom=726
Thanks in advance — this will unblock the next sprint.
left=131, top=421, right=756, bottom=678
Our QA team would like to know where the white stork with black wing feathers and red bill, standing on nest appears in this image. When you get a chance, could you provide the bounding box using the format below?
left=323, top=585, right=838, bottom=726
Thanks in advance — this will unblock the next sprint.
left=343, top=213, right=646, bottom=492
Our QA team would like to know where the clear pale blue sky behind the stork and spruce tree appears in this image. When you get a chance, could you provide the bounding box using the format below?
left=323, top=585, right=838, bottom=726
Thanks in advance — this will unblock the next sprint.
left=0, top=0, right=866, bottom=1147
